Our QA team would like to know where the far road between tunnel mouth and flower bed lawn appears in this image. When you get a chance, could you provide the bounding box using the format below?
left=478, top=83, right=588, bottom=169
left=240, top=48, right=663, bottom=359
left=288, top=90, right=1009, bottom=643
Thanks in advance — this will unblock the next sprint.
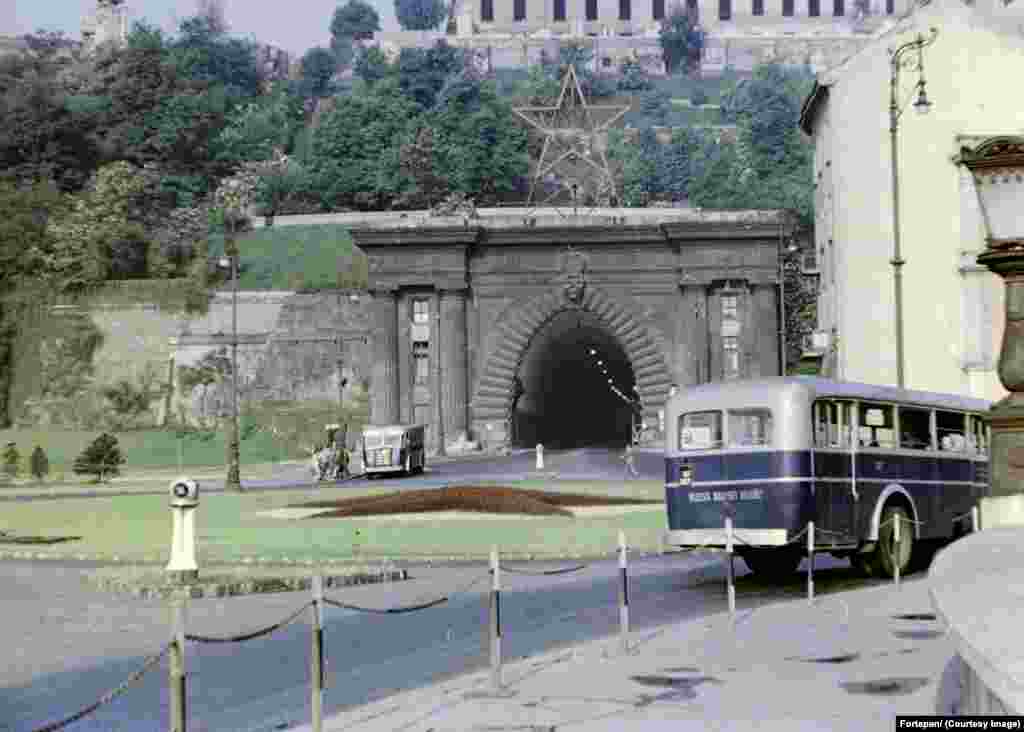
left=0, top=447, right=665, bottom=502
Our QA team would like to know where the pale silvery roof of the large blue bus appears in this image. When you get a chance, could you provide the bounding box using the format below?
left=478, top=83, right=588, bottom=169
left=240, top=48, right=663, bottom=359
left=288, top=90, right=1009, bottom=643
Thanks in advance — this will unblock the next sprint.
left=677, top=376, right=992, bottom=412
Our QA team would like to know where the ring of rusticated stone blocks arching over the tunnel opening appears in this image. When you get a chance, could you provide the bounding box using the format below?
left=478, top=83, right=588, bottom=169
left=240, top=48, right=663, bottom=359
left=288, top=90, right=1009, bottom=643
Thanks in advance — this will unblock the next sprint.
left=472, top=285, right=672, bottom=425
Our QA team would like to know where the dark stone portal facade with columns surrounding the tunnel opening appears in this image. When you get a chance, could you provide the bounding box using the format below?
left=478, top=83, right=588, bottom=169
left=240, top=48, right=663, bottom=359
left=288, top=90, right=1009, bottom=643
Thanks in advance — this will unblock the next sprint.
left=352, top=209, right=791, bottom=447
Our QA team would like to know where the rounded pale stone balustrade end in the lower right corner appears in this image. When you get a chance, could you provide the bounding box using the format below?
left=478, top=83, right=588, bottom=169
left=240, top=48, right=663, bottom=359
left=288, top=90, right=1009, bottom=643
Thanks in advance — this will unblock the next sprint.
left=928, top=521, right=1024, bottom=715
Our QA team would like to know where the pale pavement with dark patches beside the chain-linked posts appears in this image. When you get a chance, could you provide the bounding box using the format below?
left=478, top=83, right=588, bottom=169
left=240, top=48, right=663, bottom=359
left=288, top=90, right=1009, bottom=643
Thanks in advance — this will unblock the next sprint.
left=293, top=577, right=953, bottom=732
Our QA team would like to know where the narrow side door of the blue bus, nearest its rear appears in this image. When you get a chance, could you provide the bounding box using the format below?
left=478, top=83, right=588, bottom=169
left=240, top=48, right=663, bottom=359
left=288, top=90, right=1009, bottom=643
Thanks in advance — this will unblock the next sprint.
left=813, top=399, right=857, bottom=541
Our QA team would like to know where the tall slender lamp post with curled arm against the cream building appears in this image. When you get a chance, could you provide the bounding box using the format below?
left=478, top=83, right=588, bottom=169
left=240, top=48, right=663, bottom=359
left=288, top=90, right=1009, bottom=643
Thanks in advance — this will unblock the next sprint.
left=889, top=28, right=939, bottom=389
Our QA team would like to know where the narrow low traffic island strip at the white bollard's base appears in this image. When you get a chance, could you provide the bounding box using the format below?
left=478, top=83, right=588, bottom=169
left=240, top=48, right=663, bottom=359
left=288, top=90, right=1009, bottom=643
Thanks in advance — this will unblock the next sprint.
left=85, top=569, right=410, bottom=600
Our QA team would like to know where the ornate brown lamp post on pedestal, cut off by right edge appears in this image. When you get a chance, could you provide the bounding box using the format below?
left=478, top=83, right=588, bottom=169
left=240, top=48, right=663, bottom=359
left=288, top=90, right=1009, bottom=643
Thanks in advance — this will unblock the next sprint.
left=955, top=136, right=1024, bottom=528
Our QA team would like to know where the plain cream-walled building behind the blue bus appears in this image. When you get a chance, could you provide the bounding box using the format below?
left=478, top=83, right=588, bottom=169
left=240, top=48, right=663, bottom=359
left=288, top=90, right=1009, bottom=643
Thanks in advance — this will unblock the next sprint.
left=801, top=0, right=1024, bottom=399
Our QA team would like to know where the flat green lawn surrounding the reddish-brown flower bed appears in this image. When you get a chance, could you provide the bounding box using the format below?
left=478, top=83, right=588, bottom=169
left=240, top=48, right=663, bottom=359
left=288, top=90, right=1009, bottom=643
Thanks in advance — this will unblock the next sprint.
left=0, top=480, right=666, bottom=565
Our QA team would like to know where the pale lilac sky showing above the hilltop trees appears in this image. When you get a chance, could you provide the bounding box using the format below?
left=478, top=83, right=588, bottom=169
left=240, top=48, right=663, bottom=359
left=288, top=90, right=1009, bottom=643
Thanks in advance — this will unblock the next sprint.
left=12, top=0, right=398, bottom=56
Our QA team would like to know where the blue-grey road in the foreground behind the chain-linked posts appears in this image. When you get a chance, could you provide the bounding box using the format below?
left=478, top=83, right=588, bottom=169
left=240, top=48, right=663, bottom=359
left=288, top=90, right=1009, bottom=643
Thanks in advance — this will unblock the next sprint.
left=0, top=555, right=864, bottom=732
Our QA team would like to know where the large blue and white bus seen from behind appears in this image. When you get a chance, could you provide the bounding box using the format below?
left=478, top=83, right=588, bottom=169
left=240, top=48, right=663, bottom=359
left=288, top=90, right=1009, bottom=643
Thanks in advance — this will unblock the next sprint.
left=665, top=377, right=990, bottom=576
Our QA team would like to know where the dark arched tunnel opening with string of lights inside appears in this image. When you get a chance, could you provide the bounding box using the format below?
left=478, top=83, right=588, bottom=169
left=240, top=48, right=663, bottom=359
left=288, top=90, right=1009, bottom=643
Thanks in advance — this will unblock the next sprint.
left=511, top=310, right=640, bottom=449
